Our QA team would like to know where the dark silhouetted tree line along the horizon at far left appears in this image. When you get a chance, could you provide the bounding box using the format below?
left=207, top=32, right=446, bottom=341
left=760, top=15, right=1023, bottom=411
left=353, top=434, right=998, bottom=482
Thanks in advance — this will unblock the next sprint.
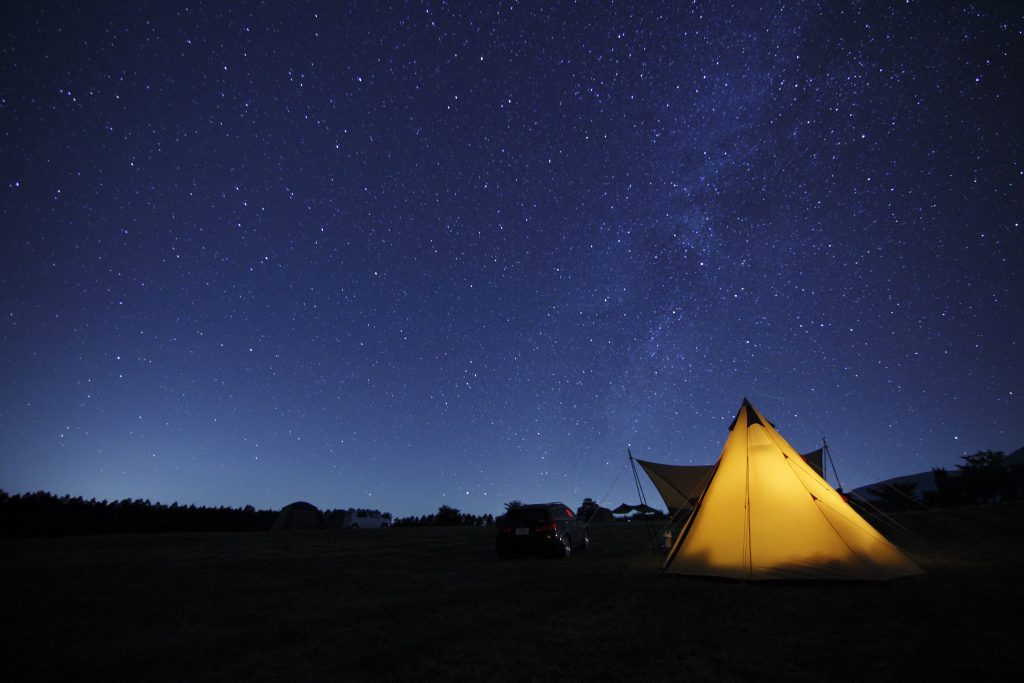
left=0, top=490, right=278, bottom=539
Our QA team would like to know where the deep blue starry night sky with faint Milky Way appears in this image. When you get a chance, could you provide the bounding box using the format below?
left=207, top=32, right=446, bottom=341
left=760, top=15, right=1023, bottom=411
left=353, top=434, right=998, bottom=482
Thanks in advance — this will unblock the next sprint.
left=0, top=2, right=1024, bottom=515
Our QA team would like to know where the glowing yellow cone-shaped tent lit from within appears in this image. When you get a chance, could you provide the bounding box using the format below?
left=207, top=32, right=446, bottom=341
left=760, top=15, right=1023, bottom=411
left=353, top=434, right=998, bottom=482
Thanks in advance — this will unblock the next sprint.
left=664, top=398, right=923, bottom=581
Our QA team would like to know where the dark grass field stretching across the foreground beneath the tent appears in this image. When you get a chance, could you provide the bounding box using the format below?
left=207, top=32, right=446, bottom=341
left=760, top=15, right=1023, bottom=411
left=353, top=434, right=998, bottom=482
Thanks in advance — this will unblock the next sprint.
left=0, top=505, right=1024, bottom=681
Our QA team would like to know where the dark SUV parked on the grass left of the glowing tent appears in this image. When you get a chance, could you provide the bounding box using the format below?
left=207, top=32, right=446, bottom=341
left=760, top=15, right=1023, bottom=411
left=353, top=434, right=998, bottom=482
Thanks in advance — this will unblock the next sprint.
left=495, top=503, right=590, bottom=558
